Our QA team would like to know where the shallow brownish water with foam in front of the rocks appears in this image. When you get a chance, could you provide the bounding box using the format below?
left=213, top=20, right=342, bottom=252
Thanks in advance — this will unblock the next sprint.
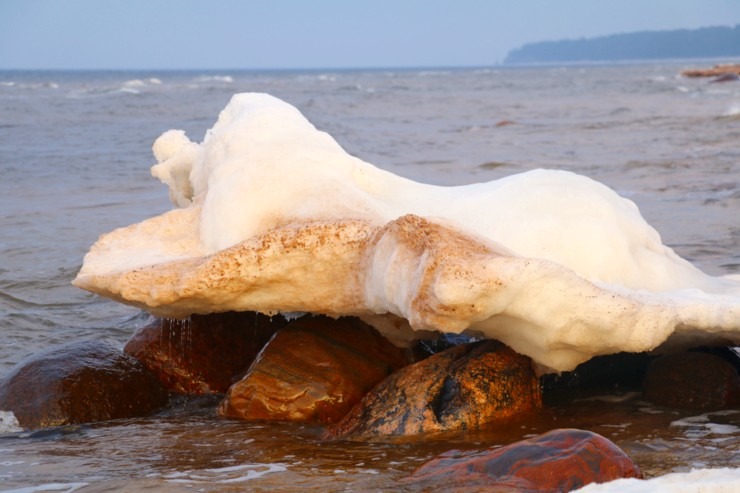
left=0, top=394, right=740, bottom=492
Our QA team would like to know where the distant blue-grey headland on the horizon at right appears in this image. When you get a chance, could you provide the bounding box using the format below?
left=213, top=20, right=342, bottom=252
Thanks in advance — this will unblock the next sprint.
left=504, top=25, right=740, bottom=64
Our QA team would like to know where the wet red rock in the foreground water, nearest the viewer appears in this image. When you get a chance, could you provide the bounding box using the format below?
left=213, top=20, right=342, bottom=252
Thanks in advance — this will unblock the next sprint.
left=402, top=429, right=642, bottom=493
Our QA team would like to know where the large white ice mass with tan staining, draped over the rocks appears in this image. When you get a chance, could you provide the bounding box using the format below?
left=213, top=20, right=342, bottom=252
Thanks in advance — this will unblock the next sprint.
left=74, top=94, right=740, bottom=371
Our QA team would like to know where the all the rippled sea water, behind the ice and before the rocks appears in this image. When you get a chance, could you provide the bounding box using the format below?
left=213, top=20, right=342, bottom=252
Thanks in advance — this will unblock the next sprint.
left=0, top=60, right=740, bottom=492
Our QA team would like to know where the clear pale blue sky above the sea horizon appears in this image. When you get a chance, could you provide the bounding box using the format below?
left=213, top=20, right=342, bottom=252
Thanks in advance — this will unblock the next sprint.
left=0, top=0, right=740, bottom=70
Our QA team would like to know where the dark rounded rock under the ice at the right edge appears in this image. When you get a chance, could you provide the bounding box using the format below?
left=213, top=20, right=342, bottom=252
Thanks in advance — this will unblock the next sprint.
left=643, top=352, right=740, bottom=410
